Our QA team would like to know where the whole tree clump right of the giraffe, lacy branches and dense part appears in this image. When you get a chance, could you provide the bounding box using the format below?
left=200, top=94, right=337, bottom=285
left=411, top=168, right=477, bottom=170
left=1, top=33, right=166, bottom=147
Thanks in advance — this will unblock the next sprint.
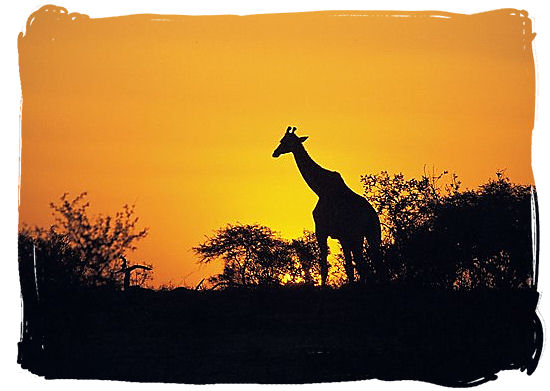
left=361, top=172, right=533, bottom=288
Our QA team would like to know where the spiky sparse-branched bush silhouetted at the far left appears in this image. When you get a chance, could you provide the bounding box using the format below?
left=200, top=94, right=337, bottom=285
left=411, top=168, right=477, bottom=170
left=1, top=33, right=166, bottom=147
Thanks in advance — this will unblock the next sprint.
left=19, top=193, right=151, bottom=287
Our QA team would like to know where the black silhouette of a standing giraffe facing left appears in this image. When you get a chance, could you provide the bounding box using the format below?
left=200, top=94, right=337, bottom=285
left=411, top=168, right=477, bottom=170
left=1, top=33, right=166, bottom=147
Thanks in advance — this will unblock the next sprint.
left=273, top=126, right=384, bottom=285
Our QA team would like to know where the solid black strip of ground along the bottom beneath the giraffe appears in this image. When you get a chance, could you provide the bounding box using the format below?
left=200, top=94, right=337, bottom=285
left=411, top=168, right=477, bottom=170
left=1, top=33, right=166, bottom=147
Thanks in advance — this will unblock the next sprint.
left=18, top=287, right=543, bottom=387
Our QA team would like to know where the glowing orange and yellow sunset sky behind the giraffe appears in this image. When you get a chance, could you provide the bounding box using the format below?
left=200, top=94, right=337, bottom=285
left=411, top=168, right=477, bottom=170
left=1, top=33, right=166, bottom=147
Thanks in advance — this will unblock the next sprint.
left=19, top=6, right=535, bottom=285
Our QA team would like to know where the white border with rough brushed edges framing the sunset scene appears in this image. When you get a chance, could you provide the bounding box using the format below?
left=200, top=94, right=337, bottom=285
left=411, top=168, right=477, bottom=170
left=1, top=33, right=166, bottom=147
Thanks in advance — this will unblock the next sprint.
left=0, top=0, right=550, bottom=391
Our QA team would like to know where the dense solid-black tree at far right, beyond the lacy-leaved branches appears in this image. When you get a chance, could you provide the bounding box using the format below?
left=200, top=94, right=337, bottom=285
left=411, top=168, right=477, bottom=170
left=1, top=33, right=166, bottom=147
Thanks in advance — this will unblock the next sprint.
left=426, top=172, right=534, bottom=288
